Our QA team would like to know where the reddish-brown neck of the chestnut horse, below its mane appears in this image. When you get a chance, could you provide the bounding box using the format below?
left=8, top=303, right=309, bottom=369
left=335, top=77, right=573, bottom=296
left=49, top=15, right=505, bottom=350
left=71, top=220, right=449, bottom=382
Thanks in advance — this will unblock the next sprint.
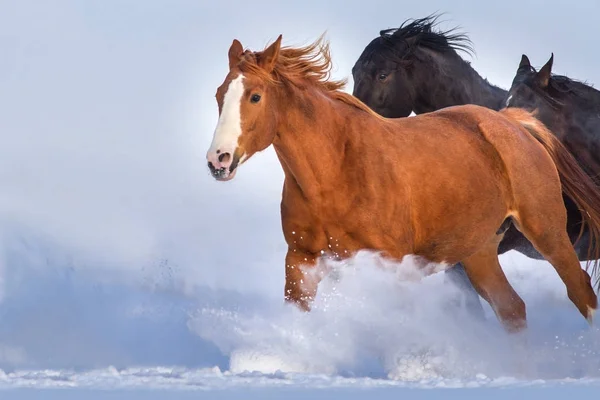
left=273, top=89, right=360, bottom=203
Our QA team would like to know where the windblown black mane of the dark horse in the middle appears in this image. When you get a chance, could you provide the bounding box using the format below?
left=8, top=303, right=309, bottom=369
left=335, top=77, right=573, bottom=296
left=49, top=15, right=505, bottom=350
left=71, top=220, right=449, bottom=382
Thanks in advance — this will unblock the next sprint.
left=379, top=14, right=475, bottom=58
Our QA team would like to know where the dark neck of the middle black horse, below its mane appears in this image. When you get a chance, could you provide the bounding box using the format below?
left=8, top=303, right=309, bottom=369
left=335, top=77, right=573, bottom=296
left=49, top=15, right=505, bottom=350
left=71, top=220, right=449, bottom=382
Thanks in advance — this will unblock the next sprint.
left=413, top=50, right=507, bottom=114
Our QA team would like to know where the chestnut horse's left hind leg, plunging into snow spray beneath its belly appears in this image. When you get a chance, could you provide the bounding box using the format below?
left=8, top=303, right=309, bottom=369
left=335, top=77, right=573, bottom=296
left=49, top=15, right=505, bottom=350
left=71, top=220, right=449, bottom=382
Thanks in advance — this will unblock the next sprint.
left=462, top=234, right=527, bottom=332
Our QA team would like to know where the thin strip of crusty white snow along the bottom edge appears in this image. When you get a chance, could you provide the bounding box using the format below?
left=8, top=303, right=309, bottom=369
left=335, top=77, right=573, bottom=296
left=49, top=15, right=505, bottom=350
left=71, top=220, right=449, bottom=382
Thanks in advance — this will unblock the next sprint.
left=0, top=367, right=600, bottom=391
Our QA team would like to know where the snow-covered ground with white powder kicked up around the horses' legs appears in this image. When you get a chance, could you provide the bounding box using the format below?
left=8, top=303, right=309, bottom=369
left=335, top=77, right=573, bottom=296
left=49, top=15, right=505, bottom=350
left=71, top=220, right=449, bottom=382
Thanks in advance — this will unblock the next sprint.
left=0, top=230, right=600, bottom=398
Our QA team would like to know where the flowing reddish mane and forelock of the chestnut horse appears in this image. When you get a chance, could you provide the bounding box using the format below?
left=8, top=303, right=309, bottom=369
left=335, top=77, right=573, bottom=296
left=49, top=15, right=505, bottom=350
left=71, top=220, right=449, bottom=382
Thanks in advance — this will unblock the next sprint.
left=239, top=35, right=383, bottom=119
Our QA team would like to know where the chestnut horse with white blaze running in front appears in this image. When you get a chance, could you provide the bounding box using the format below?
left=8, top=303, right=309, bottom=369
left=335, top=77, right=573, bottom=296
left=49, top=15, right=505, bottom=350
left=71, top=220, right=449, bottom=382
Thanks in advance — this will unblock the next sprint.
left=207, top=36, right=600, bottom=332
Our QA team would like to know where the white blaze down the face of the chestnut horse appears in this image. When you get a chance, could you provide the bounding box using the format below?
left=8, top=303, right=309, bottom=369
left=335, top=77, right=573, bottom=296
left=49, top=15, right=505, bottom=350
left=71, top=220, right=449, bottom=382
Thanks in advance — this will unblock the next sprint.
left=208, top=74, right=244, bottom=156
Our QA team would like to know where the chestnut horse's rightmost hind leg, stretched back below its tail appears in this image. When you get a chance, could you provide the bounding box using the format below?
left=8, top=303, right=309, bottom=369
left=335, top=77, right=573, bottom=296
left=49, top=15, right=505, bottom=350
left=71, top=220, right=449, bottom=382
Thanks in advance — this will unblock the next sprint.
left=514, top=209, right=598, bottom=324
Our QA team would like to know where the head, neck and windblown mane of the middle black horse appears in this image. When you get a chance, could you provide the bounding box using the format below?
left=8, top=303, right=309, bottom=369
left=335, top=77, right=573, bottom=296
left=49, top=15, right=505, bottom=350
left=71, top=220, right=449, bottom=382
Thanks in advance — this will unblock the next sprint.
left=352, top=16, right=507, bottom=118
